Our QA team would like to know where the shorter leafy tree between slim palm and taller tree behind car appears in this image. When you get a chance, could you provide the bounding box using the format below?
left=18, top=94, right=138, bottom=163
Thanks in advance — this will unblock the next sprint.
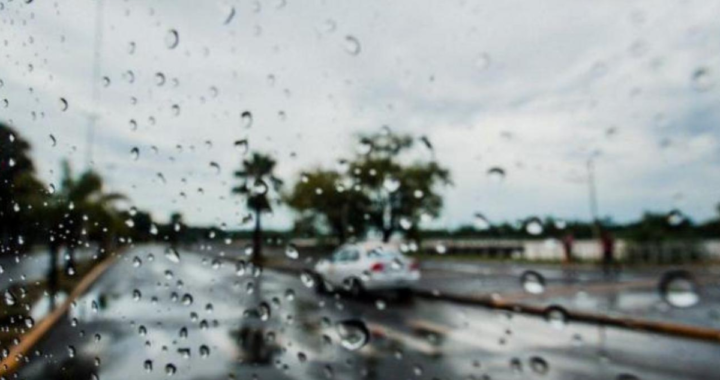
left=285, top=169, right=370, bottom=242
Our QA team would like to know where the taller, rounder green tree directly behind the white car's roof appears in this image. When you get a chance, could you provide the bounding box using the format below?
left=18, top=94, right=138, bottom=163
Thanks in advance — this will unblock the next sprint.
left=350, top=129, right=451, bottom=241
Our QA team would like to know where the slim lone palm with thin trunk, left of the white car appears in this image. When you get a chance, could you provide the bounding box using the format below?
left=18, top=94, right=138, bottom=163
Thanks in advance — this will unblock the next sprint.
left=232, top=152, right=282, bottom=264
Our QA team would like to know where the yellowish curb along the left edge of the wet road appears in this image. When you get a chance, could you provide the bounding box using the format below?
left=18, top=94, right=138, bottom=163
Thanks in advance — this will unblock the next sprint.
left=0, top=256, right=119, bottom=379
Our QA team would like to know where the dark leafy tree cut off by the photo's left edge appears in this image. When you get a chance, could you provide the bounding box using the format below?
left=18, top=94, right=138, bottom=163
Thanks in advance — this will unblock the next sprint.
left=0, top=123, right=44, bottom=253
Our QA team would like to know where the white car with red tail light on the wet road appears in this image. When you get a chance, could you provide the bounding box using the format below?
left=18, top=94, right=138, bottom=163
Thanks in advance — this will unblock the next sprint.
left=315, top=243, right=420, bottom=295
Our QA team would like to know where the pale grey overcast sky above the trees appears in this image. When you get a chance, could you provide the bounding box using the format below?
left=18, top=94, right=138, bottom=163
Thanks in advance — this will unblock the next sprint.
left=0, top=0, right=720, bottom=228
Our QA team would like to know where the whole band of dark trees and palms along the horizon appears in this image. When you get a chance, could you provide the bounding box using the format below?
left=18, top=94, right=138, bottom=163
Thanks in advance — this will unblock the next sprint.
left=0, top=120, right=720, bottom=284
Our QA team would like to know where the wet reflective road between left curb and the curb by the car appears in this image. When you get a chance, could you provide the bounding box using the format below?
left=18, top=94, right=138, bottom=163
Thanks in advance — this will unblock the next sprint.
left=12, top=247, right=720, bottom=380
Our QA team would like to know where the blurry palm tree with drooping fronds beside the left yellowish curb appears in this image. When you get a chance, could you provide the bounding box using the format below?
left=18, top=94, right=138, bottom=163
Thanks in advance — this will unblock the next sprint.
left=44, top=161, right=125, bottom=303
